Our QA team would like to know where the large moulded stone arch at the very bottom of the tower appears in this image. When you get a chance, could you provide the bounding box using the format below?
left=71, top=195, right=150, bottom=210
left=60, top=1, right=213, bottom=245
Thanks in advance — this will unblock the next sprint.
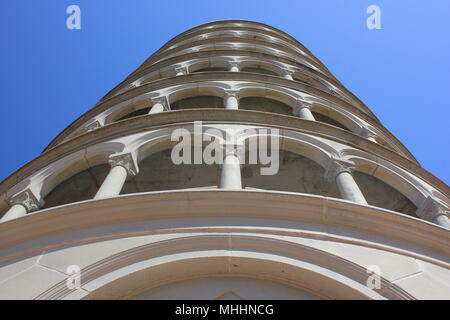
left=33, top=233, right=413, bottom=299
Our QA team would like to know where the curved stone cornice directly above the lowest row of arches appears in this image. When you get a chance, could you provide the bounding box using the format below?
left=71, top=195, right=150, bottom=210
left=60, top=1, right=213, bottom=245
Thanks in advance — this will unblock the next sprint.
left=0, top=109, right=450, bottom=198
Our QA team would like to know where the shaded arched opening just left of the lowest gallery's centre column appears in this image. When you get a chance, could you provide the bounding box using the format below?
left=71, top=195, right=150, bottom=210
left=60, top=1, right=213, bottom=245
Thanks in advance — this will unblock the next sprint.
left=122, top=147, right=220, bottom=194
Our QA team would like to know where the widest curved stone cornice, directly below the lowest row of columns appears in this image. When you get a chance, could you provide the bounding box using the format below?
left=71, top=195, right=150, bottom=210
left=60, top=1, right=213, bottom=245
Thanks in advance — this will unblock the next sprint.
left=0, top=190, right=450, bottom=268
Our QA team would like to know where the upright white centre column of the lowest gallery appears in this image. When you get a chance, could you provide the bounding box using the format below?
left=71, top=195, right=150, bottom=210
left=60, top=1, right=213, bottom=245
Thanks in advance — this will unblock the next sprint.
left=219, top=144, right=242, bottom=189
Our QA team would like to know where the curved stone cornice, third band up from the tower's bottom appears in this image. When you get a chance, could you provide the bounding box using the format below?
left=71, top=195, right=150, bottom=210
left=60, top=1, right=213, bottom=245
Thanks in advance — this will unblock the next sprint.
left=44, top=72, right=398, bottom=156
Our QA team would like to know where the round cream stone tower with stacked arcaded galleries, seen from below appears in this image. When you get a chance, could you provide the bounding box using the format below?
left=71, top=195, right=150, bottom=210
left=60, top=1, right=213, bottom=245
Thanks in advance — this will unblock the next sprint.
left=0, top=20, right=450, bottom=299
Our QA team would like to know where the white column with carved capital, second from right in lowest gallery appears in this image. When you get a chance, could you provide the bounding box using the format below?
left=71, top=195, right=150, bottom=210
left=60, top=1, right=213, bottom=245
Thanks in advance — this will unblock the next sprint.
left=326, top=159, right=367, bottom=205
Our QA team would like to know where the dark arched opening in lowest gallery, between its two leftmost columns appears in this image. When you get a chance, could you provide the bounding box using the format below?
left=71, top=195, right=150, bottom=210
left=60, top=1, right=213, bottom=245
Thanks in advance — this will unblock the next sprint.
left=42, top=164, right=110, bottom=209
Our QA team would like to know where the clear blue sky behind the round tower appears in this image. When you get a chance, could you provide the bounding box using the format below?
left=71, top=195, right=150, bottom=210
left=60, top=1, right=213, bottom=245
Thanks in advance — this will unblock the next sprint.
left=0, top=0, right=450, bottom=184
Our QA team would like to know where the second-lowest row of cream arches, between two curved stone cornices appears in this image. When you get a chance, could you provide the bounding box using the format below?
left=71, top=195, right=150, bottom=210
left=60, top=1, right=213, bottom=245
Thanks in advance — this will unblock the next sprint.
left=77, top=81, right=394, bottom=154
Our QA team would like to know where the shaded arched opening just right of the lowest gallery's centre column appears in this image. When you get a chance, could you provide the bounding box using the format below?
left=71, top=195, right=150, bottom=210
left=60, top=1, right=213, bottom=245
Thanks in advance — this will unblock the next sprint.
left=241, top=150, right=340, bottom=198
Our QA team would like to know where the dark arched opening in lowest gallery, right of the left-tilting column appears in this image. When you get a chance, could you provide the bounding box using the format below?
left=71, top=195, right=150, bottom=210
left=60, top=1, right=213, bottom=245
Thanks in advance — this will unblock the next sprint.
left=353, top=171, right=417, bottom=216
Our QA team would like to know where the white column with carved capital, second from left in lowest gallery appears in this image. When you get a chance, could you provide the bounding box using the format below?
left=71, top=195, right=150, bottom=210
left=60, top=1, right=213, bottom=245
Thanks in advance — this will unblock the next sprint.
left=94, top=153, right=137, bottom=199
